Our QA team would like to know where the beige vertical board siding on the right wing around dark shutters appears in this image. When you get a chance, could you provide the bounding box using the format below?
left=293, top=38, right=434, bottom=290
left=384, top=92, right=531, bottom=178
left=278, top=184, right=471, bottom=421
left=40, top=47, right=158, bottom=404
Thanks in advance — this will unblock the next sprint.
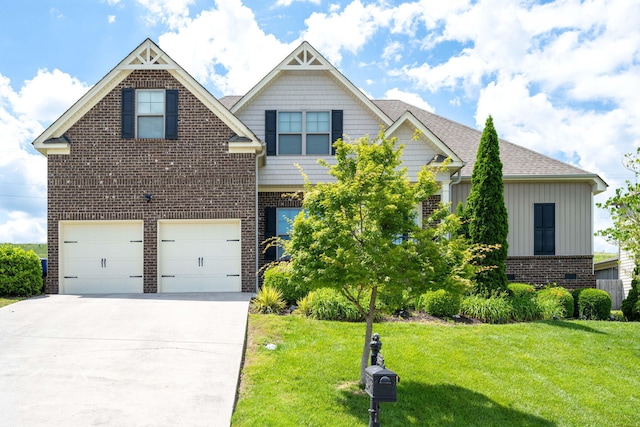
left=451, top=181, right=593, bottom=256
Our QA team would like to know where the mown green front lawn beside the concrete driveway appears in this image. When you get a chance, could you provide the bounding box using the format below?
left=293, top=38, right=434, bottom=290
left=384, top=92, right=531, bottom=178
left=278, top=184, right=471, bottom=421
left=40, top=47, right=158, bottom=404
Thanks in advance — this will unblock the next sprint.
left=232, top=315, right=640, bottom=427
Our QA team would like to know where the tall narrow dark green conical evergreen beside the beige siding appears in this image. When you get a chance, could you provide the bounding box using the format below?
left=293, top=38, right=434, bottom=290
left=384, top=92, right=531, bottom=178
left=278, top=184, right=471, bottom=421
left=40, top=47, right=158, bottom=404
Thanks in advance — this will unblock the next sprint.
left=464, top=116, right=509, bottom=296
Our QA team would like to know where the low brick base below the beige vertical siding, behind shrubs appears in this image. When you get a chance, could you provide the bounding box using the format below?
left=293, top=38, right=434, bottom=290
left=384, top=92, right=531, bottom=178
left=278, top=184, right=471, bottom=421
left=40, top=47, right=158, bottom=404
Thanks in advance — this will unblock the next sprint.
left=507, top=255, right=596, bottom=289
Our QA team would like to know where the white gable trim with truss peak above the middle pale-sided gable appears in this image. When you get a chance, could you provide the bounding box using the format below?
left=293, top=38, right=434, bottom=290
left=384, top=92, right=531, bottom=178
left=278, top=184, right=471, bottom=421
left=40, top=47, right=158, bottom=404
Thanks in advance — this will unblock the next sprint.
left=231, top=41, right=393, bottom=127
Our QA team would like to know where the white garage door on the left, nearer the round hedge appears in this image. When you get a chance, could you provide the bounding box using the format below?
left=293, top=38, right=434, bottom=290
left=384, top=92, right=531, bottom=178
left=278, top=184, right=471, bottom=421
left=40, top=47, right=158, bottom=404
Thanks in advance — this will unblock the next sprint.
left=60, top=221, right=143, bottom=294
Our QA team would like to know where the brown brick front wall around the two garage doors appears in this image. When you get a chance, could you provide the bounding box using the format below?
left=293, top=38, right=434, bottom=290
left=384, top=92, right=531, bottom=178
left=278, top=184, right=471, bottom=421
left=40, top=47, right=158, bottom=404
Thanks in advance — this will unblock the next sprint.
left=45, top=70, right=256, bottom=293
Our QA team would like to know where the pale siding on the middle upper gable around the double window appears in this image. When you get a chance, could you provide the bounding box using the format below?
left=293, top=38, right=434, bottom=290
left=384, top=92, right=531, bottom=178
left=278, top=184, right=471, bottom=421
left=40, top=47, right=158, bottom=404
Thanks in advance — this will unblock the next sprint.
left=236, top=70, right=382, bottom=186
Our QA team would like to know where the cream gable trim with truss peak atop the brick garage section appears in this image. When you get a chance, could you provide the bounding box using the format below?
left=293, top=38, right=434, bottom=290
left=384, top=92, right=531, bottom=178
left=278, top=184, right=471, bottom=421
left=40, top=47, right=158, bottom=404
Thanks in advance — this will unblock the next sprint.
left=33, top=39, right=262, bottom=155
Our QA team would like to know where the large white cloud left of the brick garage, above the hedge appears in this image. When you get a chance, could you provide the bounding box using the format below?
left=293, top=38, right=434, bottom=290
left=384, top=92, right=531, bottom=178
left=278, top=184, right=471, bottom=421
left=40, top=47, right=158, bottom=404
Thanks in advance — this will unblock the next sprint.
left=0, top=70, right=88, bottom=243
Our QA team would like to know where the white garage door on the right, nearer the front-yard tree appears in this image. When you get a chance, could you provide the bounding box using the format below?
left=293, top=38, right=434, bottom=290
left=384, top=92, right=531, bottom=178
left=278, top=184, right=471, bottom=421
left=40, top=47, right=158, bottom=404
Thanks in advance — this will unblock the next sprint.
left=158, top=220, right=242, bottom=292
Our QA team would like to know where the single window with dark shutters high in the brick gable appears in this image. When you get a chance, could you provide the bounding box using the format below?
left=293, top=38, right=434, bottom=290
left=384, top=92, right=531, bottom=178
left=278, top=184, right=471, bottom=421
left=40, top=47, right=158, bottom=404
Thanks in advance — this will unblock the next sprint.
left=122, top=88, right=178, bottom=139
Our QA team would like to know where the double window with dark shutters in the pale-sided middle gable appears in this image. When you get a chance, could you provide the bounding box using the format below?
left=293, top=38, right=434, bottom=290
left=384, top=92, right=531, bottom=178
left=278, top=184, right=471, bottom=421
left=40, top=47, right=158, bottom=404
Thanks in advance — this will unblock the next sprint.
left=265, top=110, right=342, bottom=156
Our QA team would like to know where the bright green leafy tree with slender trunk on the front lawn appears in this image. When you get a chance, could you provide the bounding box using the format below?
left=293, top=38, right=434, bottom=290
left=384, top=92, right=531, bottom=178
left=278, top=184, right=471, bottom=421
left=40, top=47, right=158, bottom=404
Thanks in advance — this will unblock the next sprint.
left=279, top=133, right=475, bottom=384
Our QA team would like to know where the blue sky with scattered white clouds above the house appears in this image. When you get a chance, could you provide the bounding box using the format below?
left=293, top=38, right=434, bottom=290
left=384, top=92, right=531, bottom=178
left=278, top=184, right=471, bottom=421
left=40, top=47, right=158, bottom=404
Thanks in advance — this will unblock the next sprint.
left=0, top=0, right=640, bottom=250
